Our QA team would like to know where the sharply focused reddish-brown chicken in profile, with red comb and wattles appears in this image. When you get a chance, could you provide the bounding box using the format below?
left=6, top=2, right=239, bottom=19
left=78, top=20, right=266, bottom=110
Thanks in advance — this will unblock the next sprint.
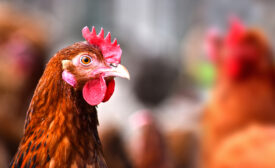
left=10, top=27, right=129, bottom=168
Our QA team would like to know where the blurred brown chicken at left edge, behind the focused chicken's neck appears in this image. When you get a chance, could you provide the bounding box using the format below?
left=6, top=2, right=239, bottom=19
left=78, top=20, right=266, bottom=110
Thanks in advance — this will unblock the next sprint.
left=0, top=3, right=47, bottom=155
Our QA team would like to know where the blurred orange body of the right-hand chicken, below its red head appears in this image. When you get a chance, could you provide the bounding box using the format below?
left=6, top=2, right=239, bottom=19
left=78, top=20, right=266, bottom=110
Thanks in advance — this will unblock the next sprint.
left=203, top=76, right=275, bottom=167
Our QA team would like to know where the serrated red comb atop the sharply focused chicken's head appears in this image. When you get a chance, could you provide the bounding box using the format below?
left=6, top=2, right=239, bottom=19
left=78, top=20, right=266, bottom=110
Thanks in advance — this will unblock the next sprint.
left=82, top=26, right=122, bottom=63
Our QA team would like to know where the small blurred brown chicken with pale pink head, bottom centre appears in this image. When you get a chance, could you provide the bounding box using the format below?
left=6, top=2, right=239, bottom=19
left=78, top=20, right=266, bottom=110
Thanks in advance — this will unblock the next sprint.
left=130, top=111, right=172, bottom=168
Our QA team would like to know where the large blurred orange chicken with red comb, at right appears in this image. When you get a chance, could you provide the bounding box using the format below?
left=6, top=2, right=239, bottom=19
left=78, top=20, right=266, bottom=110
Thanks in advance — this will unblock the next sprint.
left=202, top=19, right=275, bottom=167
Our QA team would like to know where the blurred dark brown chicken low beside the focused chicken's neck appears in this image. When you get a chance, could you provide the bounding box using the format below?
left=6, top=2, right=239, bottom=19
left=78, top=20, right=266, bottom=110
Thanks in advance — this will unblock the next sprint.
left=99, top=125, right=133, bottom=168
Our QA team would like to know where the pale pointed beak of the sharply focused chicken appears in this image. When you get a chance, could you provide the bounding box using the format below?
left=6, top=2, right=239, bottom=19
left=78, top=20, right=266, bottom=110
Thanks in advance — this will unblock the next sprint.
left=93, top=64, right=130, bottom=80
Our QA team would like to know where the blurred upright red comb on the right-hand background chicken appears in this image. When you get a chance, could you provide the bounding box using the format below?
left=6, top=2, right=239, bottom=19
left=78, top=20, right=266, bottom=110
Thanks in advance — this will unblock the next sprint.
left=226, top=17, right=245, bottom=46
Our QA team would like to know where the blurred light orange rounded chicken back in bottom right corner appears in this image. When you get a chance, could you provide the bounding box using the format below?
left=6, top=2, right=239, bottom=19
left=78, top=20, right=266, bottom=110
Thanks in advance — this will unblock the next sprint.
left=211, top=125, right=275, bottom=168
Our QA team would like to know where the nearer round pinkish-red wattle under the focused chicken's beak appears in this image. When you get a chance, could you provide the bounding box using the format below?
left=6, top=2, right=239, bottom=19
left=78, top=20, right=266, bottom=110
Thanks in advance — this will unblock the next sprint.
left=82, top=77, right=107, bottom=106
